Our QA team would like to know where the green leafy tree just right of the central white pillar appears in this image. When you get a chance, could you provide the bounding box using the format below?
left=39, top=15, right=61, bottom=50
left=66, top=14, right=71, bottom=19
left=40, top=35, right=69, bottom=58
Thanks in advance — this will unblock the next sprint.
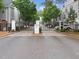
left=43, top=0, right=60, bottom=22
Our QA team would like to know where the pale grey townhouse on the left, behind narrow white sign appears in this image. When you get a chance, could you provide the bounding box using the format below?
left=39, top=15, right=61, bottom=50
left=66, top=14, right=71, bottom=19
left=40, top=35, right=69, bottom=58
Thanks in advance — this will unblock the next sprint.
left=0, top=0, right=19, bottom=31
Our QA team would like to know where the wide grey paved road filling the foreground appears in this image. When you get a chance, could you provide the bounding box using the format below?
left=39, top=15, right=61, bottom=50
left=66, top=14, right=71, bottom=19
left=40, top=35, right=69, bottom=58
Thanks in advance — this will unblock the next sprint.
left=0, top=32, right=79, bottom=59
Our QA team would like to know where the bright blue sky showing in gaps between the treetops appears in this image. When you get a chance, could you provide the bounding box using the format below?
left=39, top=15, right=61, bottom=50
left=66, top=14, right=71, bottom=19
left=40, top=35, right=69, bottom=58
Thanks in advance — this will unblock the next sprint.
left=33, top=0, right=63, bottom=11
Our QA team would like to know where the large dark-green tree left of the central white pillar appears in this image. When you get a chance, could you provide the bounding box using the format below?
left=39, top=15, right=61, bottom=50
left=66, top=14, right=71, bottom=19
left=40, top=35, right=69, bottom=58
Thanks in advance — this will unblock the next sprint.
left=13, top=0, right=37, bottom=22
